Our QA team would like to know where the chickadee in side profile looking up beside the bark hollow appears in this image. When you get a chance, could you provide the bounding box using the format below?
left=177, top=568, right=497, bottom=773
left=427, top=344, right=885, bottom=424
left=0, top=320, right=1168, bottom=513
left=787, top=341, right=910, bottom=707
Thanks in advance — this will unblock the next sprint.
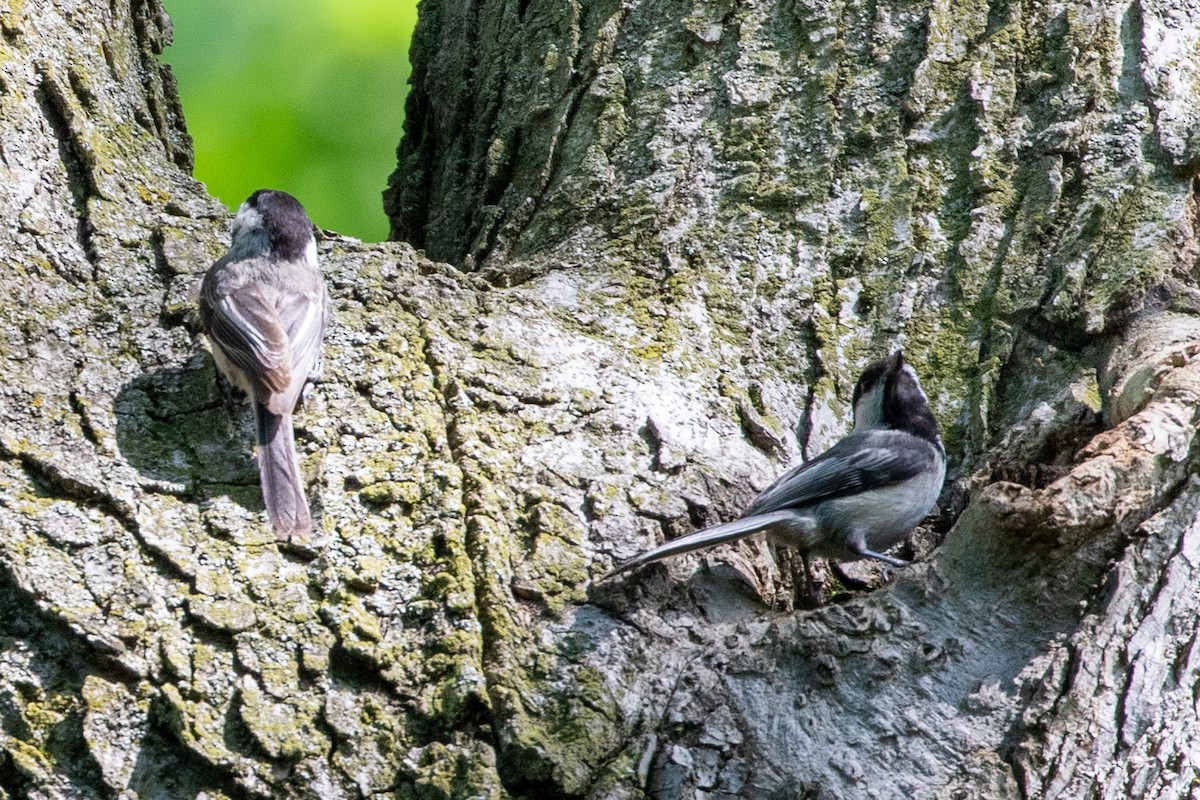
left=600, top=351, right=946, bottom=585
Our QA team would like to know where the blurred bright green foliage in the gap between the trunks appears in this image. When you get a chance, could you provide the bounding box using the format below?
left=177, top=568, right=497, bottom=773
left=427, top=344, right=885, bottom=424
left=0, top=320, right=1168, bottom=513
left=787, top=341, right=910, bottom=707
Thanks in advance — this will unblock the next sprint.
left=163, top=0, right=416, bottom=241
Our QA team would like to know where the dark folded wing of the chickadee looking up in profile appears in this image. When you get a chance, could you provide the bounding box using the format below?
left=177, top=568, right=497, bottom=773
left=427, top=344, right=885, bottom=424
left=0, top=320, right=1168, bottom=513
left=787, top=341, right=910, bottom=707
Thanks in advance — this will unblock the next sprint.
left=744, top=431, right=935, bottom=517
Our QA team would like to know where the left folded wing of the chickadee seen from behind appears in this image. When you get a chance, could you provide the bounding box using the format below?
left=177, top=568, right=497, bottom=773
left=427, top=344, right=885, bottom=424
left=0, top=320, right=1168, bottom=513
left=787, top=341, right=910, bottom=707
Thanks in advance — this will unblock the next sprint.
left=200, top=266, right=292, bottom=393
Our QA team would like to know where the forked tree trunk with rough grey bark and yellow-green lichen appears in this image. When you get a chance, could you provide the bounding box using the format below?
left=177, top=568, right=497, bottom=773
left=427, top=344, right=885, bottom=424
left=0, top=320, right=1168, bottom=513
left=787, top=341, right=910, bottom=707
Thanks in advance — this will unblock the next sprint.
left=0, top=0, right=1200, bottom=800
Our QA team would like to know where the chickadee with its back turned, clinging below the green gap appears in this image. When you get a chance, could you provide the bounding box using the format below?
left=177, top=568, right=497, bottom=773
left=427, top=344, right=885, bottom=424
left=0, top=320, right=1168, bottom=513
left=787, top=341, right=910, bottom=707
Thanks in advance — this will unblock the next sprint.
left=200, top=190, right=329, bottom=541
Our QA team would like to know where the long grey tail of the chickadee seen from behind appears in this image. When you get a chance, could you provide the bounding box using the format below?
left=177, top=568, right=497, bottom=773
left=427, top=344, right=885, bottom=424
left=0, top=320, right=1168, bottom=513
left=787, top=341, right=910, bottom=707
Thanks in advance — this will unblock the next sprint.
left=254, top=403, right=312, bottom=541
